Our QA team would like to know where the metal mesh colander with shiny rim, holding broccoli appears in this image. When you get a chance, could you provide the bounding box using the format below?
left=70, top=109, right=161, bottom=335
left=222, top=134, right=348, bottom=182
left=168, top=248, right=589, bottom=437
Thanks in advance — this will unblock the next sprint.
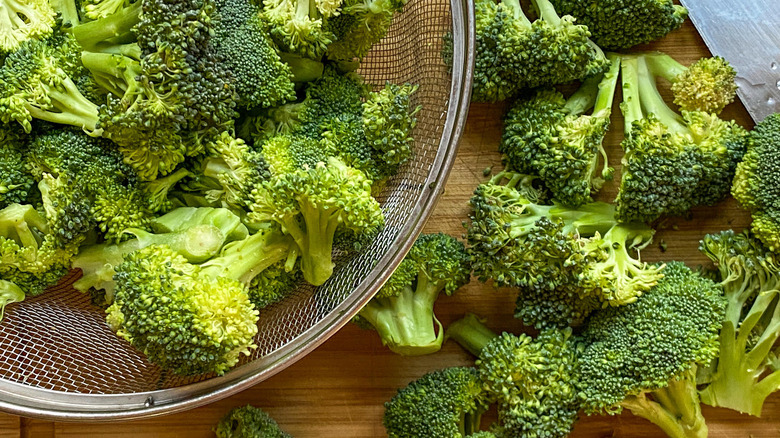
left=0, top=0, right=474, bottom=421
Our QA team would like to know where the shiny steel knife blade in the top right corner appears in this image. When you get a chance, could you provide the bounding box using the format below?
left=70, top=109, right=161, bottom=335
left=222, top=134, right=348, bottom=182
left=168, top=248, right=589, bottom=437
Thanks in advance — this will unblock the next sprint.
left=680, top=0, right=780, bottom=122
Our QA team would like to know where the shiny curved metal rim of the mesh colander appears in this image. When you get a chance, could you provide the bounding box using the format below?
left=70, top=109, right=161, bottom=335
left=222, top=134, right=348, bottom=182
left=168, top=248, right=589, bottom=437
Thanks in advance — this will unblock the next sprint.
left=0, top=0, right=475, bottom=421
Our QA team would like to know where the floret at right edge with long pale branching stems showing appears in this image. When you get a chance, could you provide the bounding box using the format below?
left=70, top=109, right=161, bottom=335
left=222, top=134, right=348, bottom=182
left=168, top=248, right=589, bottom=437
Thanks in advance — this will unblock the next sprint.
left=700, top=230, right=780, bottom=417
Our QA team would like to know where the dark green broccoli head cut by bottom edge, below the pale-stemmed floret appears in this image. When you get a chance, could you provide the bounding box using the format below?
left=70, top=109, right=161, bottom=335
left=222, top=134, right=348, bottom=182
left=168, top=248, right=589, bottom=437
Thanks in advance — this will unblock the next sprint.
left=383, top=367, right=488, bottom=438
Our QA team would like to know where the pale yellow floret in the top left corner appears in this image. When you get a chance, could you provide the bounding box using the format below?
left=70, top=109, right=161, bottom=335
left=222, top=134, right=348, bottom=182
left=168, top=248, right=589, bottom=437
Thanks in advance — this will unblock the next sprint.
left=0, top=0, right=56, bottom=54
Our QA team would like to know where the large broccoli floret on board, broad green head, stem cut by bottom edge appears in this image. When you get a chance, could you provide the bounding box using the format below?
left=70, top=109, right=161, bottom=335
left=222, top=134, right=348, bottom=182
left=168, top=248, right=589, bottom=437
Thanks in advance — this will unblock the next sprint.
left=579, top=262, right=726, bottom=437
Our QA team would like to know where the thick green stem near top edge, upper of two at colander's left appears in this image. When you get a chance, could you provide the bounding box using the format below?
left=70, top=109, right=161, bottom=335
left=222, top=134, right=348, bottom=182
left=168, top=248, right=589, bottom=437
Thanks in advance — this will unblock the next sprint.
left=73, top=1, right=143, bottom=54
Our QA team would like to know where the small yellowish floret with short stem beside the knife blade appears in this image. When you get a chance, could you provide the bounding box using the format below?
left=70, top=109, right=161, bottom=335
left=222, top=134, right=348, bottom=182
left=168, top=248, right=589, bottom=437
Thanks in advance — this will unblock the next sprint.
left=647, top=52, right=737, bottom=114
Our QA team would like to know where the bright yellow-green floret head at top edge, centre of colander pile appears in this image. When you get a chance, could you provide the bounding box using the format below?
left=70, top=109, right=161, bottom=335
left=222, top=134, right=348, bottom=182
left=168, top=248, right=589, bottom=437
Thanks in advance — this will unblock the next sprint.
left=262, top=0, right=341, bottom=59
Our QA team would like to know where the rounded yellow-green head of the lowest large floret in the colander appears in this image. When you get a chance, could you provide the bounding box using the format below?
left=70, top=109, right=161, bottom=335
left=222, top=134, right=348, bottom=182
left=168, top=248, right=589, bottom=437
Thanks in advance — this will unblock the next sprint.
left=106, top=245, right=258, bottom=375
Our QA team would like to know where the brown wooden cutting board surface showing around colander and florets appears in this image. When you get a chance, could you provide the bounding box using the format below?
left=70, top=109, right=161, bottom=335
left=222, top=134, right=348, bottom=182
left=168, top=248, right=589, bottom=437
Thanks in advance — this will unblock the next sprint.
left=0, top=13, right=780, bottom=438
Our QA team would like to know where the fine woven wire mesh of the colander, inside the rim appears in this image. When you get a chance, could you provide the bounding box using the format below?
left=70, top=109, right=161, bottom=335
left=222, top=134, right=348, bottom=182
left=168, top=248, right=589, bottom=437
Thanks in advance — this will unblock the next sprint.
left=0, top=0, right=452, bottom=395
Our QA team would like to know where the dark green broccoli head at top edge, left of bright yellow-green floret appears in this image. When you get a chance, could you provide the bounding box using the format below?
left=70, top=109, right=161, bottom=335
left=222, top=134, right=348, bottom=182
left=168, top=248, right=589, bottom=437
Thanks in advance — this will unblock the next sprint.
left=211, top=0, right=295, bottom=108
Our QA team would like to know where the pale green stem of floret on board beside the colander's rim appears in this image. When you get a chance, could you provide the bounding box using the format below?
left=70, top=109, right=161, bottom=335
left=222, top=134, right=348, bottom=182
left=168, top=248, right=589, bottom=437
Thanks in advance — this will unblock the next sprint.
left=360, top=273, right=444, bottom=356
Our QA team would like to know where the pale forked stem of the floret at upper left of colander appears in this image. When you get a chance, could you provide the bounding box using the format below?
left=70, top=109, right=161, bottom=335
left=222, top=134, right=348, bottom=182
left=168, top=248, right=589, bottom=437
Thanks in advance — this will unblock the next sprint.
left=25, top=76, right=99, bottom=135
